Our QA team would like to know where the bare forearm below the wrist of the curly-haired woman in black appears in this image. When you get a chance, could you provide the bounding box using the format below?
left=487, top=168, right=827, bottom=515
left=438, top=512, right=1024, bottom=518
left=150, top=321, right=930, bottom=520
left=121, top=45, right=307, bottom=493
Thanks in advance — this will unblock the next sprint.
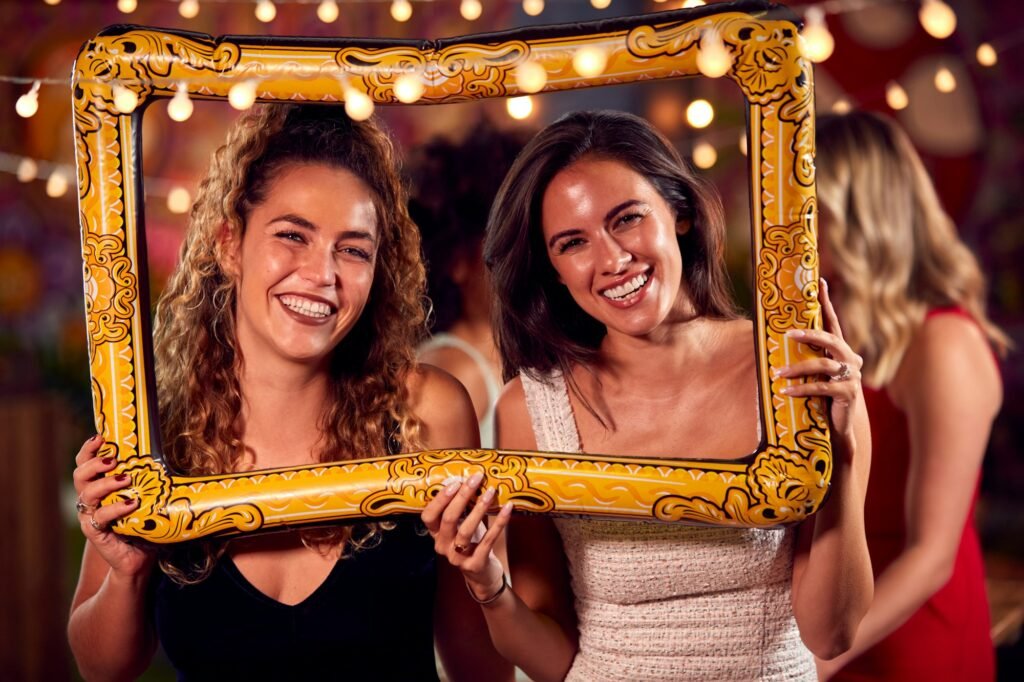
left=68, top=572, right=156, bottom=682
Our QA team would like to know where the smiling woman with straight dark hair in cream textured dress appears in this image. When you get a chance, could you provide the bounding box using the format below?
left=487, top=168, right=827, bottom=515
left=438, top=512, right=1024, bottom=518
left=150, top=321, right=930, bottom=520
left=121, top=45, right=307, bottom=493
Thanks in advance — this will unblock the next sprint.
left=423, top=112, right=871, bottom=680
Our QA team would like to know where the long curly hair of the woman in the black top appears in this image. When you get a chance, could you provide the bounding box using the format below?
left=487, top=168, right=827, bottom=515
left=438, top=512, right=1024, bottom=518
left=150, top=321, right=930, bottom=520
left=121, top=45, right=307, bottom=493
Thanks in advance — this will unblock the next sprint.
left=154, top=103, right=426, bottom=582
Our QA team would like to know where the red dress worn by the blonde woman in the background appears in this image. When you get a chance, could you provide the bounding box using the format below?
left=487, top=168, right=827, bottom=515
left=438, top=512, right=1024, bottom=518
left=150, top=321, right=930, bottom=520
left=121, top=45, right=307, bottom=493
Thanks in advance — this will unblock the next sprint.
left=833, top=308, right=995, bottom=682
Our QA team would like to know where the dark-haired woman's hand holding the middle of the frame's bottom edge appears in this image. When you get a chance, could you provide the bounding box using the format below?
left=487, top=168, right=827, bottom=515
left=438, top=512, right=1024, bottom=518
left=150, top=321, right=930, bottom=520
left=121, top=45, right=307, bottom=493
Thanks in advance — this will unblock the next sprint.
left=420, top=473, right=512, bottom=601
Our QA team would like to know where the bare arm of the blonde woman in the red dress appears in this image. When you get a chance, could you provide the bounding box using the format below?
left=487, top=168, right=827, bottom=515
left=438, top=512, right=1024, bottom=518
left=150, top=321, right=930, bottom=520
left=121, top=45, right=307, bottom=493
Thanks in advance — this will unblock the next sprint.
left=819, top=315, right=1002, bottom=678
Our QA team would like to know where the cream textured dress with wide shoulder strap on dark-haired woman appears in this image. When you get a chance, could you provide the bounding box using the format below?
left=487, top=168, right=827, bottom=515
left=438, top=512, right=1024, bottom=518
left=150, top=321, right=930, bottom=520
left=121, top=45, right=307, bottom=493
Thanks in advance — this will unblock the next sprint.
left=520, top=373, right=817, bottom=682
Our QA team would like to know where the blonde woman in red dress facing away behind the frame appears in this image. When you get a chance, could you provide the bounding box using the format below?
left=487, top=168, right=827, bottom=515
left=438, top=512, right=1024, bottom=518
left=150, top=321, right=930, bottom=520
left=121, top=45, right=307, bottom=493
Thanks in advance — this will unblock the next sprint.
left=817, top=112, right=1009, bottom=680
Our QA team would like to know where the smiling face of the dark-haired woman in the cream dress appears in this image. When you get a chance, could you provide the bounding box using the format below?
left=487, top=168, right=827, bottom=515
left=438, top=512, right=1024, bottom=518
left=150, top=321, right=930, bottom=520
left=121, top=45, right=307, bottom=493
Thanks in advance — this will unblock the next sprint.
left=542, top=158, right=685, bottom=336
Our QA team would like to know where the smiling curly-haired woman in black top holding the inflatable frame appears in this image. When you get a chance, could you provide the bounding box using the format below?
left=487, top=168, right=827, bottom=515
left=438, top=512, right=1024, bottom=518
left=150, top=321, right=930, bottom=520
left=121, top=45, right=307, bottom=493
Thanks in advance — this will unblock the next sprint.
left=69, top=104, right=507, bottom=680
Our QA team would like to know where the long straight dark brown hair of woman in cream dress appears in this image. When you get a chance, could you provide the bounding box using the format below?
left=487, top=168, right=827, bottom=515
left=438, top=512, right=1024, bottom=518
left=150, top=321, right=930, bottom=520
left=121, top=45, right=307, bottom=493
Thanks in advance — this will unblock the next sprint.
left=484, top=111, right=736, bottom=380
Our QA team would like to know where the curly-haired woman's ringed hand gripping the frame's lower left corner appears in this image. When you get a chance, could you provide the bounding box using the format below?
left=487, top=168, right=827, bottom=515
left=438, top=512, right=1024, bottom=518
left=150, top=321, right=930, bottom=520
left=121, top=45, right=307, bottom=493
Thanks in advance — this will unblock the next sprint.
left=73, top=435, right=155, bottom=578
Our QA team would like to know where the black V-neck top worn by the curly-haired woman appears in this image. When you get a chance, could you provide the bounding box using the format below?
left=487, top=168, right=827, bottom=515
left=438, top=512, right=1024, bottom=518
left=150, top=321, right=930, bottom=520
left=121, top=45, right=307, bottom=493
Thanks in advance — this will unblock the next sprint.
left=154, top=520, right=437, bottom=682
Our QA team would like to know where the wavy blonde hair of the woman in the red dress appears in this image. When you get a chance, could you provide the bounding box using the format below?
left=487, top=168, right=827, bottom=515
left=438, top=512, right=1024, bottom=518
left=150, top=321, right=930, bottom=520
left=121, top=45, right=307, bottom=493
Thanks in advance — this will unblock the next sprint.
left=816, top=112, right=1010, bottom=387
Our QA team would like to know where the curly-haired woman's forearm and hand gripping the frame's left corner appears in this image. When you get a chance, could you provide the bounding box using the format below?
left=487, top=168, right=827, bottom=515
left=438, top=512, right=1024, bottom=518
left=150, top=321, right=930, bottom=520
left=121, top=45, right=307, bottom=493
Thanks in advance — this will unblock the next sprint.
left=68, top=438, right=157, bottom=682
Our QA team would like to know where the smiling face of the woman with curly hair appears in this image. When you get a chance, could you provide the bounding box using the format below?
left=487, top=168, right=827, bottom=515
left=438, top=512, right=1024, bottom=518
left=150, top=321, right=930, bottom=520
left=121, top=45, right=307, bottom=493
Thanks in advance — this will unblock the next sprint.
left=225, top=164, right=379, bottom=367
